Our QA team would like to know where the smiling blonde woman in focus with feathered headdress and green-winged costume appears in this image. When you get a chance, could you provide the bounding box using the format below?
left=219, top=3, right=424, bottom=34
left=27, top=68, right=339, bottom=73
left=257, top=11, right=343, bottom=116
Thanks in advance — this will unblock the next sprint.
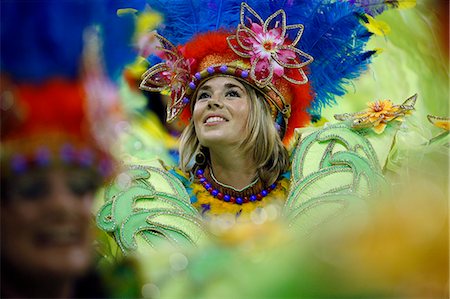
left=97, top=1, right=406, bottom=252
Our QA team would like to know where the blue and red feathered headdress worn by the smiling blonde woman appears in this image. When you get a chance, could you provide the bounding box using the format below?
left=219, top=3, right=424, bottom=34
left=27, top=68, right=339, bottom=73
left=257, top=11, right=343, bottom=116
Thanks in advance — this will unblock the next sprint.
left=141, top=0, right=392, bottom=143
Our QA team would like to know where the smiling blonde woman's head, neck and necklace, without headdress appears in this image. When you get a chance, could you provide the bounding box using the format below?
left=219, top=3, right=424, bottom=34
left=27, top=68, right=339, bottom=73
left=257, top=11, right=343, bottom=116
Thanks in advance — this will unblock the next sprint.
left=180, top=76, right=289, bottom=218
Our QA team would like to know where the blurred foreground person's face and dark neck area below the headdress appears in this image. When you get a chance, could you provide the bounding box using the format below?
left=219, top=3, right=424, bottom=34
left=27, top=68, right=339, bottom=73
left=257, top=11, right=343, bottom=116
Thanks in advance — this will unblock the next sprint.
left=1, top=158, right=105, bottom=298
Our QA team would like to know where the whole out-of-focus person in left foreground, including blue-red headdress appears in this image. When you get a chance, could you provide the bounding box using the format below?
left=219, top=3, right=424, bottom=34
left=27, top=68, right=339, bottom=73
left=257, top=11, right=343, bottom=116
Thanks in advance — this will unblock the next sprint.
left=0, top=0, right=143, bottom=298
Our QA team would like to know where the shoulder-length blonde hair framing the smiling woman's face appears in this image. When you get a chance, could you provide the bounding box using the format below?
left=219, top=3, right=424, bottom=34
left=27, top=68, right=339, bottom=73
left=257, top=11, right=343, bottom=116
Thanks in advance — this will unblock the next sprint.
left=179, top=81, right=289, bottom=185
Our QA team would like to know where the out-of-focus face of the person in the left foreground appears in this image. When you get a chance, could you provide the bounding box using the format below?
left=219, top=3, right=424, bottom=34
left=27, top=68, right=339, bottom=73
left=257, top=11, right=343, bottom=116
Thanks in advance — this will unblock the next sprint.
left=1, top=168, right=97, bottom=277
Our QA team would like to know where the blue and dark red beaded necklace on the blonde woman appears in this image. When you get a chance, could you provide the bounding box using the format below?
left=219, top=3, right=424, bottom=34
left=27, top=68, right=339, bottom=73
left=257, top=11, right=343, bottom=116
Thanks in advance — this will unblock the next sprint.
left=195, top=169, right=277, bottom=205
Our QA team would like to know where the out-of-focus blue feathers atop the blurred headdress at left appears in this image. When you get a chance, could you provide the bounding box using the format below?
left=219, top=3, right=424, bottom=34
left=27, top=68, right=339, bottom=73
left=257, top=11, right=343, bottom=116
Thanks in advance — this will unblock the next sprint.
left=0, top=0, right=141, bottom=82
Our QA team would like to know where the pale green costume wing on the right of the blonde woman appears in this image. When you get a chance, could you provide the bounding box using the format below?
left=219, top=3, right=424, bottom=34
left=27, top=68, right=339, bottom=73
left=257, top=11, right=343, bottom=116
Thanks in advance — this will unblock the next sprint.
left=283, top=123, right=396, bottom=229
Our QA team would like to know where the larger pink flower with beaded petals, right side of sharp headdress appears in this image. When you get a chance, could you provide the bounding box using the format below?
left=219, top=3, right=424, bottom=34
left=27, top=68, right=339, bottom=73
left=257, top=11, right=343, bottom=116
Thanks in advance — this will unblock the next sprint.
left=227, top=3, right=313, bottom=87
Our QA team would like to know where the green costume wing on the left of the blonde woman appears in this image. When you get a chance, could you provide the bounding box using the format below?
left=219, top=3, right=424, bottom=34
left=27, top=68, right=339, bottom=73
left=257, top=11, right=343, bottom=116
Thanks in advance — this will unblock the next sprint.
left=97, top=165, right=205, bottom=253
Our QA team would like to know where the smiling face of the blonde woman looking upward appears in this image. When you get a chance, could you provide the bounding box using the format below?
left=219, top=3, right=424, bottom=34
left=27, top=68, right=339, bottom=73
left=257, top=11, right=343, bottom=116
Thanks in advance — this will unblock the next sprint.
left=193, top=77, right=250, bottom=147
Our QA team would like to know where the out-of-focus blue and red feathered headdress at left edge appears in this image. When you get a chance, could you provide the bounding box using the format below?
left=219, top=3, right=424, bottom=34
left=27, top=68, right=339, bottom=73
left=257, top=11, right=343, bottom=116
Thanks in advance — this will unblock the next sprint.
left=1, top=0, right=141, bottom=175
